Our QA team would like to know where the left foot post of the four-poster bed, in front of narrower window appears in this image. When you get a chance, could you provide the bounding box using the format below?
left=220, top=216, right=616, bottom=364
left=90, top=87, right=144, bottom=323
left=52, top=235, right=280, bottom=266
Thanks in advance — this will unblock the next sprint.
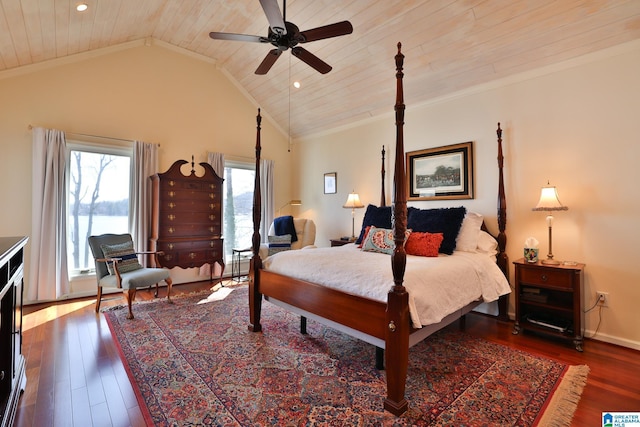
left=248, top=108, right=262, bottom=332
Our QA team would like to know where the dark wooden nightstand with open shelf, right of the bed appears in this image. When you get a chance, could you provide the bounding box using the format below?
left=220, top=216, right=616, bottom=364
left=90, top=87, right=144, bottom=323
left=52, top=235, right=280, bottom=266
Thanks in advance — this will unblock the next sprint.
left=513, top=258, right=584, bottom=351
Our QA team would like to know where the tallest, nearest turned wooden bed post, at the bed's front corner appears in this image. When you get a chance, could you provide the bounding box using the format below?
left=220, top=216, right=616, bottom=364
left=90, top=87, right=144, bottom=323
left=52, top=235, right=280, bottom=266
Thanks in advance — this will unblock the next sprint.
left=384, top=43, right=409, bottom=415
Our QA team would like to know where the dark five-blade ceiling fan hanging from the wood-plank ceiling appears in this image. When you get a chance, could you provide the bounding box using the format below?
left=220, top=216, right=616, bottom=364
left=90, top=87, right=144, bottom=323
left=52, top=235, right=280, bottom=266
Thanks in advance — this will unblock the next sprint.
left=209, top=0, right=353, bottom=74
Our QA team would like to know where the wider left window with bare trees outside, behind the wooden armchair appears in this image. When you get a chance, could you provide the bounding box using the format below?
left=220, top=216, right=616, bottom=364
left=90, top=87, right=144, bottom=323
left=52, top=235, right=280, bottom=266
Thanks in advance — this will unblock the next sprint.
left=67, top=141, right=132, bottom=277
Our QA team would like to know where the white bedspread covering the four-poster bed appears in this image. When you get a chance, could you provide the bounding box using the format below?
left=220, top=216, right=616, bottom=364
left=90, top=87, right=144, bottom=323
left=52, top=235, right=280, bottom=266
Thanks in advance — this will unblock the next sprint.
left=263, top=244, right=511, bottom=328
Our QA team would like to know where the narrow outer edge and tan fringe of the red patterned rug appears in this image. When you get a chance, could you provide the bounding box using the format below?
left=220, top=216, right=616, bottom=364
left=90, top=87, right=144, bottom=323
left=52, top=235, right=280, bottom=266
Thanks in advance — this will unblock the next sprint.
left=101, top=283, right=589, bottom=427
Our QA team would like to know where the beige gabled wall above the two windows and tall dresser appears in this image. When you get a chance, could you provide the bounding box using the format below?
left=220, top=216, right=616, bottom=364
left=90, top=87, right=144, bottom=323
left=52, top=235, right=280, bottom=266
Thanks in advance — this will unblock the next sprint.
left=0, top=42, right=292, bottom=300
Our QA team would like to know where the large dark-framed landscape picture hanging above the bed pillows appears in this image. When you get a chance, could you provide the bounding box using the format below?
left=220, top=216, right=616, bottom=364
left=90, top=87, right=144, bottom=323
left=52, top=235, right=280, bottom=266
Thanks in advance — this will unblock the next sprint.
left=406, top=142, right=473, bottom=200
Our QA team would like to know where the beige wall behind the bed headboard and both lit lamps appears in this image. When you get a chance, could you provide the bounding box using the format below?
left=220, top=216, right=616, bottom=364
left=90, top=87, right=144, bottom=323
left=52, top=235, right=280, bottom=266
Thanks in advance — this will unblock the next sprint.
left=294, top=43, right=640, bottom=351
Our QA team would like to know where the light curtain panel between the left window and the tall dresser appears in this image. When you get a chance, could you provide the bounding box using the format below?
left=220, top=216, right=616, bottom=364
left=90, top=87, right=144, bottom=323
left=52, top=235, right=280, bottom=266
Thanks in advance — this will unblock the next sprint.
left=129, top=141, right=158, bottom=267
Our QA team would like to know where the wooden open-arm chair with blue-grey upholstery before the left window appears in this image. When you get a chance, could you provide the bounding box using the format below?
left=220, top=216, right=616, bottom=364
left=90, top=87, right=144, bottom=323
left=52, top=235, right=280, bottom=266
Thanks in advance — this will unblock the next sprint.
left=88, top=234, right=173, bottom=319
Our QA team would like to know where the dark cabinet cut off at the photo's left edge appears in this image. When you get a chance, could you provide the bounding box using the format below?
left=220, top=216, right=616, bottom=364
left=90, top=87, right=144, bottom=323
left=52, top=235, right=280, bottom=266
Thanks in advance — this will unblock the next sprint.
left=0, top=237, right=27, bottom=427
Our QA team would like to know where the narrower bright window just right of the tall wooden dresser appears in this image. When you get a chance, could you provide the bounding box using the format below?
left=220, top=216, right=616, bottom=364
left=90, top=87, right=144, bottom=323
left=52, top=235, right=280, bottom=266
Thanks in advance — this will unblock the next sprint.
left=222, top=161, right=256, bottom=260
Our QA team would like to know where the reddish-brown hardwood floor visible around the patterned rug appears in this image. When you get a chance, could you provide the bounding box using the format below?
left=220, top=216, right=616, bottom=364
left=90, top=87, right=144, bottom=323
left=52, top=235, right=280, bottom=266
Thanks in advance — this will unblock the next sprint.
left=15, top=282, right=640, bottom=427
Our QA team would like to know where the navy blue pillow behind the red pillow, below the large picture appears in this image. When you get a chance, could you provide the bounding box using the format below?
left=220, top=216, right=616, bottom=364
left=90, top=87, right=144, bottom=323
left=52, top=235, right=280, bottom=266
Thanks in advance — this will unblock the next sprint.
left=407, top=206, right=467, bottom=255
